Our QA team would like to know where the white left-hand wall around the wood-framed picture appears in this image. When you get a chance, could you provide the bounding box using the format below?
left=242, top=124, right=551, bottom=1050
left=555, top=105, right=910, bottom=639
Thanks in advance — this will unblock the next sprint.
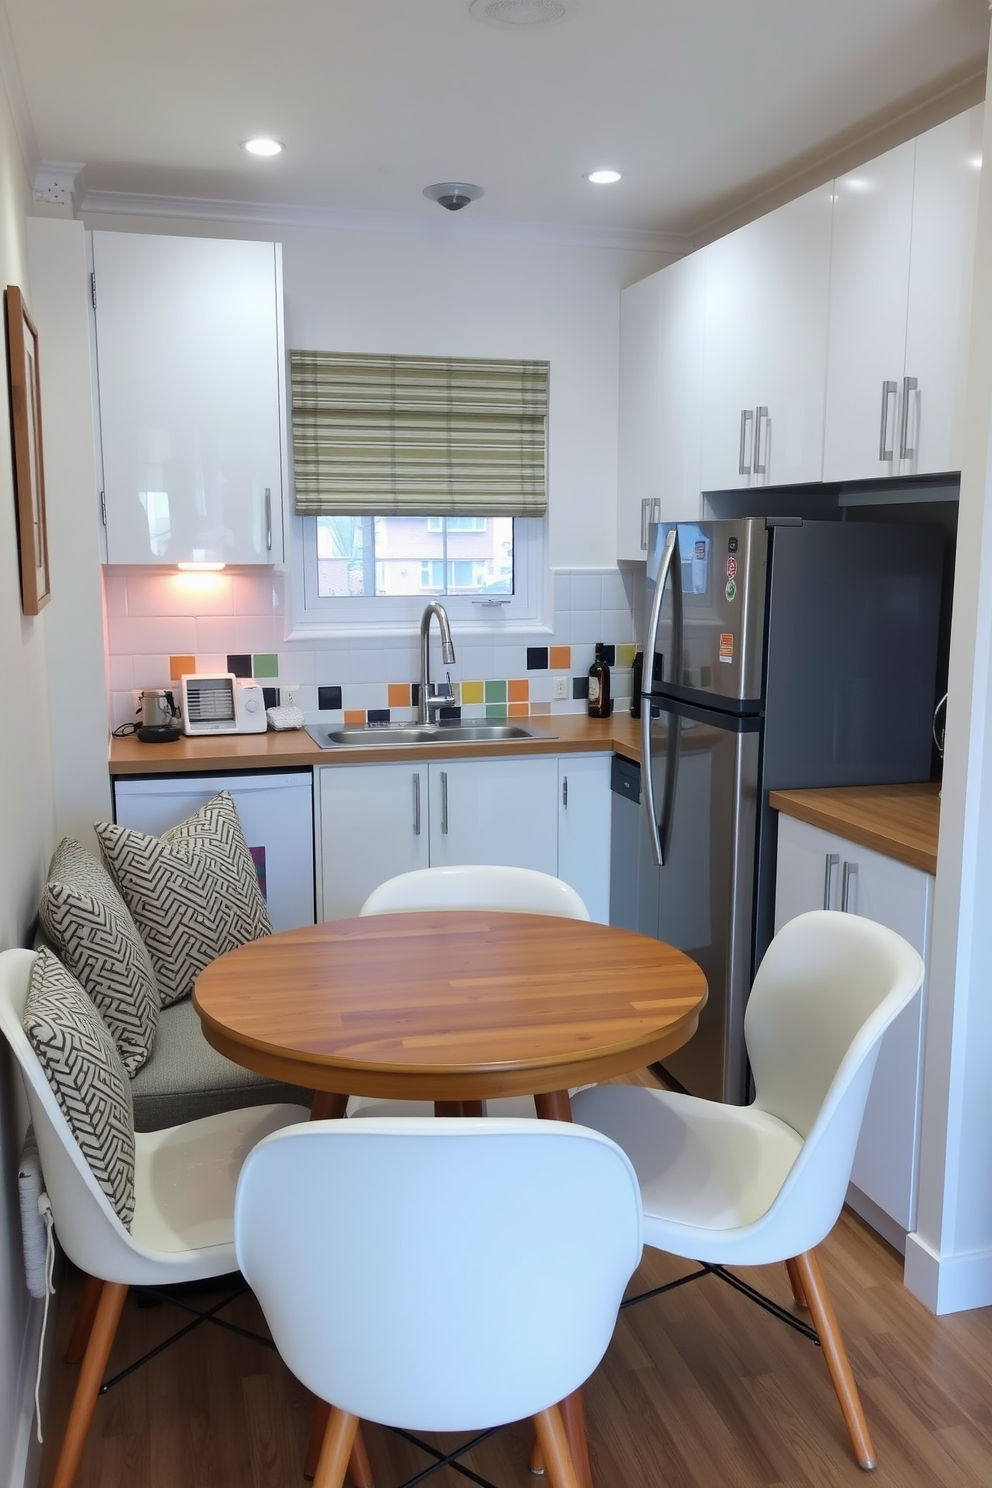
left=0, top=52, right=58, bottom=1488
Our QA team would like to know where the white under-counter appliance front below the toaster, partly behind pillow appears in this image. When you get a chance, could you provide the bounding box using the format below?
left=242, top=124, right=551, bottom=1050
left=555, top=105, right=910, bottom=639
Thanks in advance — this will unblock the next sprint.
left=115, top=769, right=315, bottom=930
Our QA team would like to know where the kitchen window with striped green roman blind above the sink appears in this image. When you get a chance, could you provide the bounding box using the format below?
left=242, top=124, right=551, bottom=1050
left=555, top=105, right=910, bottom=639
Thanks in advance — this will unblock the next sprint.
left=290, top=351, right=547, bottom=628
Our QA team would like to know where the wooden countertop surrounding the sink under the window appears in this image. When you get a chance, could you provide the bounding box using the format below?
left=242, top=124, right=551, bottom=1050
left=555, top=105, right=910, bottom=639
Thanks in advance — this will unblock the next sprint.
left=110, top=713, right=640, bottom=775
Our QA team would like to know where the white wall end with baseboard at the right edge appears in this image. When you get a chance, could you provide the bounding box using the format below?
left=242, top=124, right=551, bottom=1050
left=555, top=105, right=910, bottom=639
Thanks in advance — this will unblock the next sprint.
left=906, top=23, right=992, bottom=1312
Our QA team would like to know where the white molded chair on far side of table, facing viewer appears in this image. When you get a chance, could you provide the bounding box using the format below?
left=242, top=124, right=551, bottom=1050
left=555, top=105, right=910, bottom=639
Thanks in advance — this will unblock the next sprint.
left=356, top=863, right=589, bottom=1116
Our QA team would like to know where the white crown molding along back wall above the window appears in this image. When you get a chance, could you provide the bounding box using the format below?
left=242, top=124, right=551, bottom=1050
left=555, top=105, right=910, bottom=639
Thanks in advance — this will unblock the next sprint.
left=79, top=190, right=695, bottom=256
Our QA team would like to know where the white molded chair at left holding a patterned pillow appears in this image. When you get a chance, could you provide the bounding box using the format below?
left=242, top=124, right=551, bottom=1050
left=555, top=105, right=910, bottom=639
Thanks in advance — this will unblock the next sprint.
left=0, top=949, right=309, bottom=1488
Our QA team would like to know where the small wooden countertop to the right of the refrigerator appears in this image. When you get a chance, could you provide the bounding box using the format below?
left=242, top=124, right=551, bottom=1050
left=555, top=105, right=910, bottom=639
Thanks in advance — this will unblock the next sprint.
left=769, top=781, right=940, bottom=873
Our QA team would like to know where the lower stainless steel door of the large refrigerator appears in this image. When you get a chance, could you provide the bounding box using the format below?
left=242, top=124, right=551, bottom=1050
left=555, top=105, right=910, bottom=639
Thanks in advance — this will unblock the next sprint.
left=651, top=710, right=760, bottom=1104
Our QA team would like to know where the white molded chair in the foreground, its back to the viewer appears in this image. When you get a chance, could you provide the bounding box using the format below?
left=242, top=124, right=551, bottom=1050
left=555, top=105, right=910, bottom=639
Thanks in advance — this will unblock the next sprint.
left=235, top=1117, right=641, bottom=1488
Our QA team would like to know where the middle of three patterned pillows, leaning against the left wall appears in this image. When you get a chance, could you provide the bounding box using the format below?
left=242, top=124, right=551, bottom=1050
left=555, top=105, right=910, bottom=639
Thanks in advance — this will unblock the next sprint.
left=40, top=838, right=159, bottom=1074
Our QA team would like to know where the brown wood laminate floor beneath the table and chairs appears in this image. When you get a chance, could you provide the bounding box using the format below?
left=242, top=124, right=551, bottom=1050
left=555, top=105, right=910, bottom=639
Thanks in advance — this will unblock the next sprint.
left=40, top=1077, right=992, bottom=1488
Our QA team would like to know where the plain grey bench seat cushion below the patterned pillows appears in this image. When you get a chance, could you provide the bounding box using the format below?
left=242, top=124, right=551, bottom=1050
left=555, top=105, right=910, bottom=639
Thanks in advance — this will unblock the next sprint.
left=131, top=997, right=312, bottom=1131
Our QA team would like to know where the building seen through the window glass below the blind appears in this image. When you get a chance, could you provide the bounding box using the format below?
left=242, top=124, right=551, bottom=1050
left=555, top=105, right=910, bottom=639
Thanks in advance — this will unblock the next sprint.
left=315, top=516, right=513, bottom=600
